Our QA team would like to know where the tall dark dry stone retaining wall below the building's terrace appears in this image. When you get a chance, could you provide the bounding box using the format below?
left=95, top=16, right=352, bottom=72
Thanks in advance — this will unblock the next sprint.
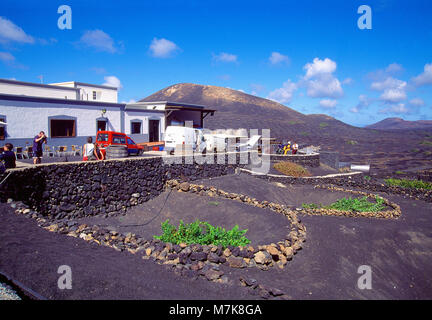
left=0, top=154, right=243, bottom=219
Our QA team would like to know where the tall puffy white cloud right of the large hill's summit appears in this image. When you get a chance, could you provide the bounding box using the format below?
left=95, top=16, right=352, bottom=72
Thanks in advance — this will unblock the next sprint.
left=301, top=58, right=343, bottom=98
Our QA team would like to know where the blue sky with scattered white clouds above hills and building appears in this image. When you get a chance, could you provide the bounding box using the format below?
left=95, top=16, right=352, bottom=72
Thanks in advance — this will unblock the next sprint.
left=0, top=0, right=432, bottom=126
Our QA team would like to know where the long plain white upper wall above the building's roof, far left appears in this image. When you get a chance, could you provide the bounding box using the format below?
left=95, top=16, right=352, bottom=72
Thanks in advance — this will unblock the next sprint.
left=0, top=82, right=77, bottom=100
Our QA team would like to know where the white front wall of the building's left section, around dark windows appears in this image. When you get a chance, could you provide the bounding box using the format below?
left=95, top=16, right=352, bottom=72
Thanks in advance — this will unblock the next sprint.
left=0, top=100, right=122, bottom=140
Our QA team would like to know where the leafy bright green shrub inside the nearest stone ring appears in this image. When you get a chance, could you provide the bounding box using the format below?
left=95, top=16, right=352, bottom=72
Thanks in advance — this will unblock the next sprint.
left=154, top=219, right=250, bottom=248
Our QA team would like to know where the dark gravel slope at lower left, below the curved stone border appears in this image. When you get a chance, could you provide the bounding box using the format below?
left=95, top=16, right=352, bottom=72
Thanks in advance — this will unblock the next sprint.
left=0, top=204, right=256, bottom=300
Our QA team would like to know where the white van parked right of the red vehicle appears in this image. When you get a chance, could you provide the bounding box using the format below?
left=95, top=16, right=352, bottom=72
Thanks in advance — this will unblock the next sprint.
left=164, top=126, right=206, bottom=154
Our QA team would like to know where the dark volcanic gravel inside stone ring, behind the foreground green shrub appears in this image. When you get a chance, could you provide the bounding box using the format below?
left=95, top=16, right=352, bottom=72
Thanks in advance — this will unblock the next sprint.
left=78, top=191, right=291, bottom=245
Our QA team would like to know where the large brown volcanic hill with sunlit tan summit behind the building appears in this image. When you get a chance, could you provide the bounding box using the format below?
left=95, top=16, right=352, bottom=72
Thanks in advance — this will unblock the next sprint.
left=141, top=83, right=365, bottom=139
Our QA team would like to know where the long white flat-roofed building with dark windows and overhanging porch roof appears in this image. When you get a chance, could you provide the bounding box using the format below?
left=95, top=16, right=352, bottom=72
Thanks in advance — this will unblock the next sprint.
left=0, top=79, right=215, bottom=147
